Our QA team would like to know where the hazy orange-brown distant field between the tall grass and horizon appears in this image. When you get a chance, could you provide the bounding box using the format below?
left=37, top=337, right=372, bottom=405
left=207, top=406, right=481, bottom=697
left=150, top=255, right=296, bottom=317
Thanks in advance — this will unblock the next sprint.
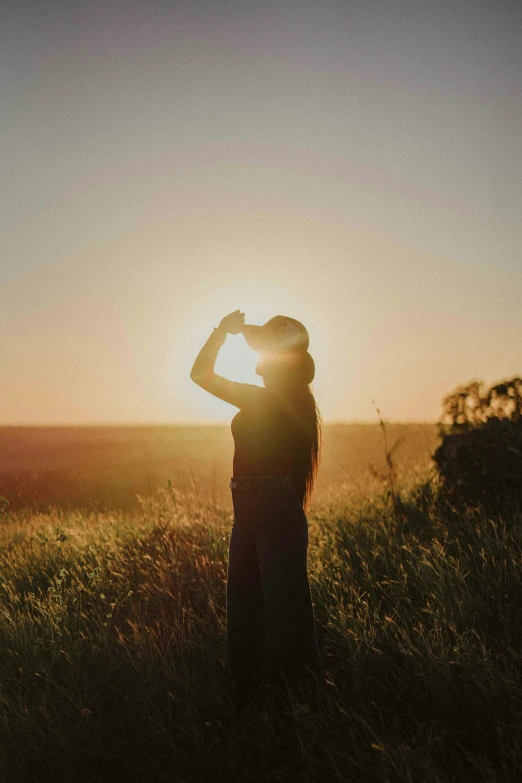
left=0, top=424, right=437, bottom=509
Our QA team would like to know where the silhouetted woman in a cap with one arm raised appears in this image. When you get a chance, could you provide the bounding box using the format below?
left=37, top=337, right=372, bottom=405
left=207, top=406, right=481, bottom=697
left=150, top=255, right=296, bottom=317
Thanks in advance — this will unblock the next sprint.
left=190, top=310, right=320, bottom=703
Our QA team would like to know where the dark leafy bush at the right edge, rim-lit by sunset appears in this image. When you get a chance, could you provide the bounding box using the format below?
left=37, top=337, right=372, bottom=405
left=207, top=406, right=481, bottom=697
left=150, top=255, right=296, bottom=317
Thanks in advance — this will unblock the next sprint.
left=433, top=378, right=522, bottom=507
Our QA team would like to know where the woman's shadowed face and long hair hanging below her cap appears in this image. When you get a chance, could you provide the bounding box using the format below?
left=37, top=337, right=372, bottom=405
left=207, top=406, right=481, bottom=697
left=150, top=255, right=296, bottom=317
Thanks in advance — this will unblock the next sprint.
left=256, top=352, right=322, bottom=509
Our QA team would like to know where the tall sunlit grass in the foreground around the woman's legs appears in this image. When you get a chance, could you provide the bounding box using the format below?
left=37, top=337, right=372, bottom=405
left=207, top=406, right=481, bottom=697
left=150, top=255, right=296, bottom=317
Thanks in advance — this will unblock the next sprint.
left=0, top=476, right=522, bottom=783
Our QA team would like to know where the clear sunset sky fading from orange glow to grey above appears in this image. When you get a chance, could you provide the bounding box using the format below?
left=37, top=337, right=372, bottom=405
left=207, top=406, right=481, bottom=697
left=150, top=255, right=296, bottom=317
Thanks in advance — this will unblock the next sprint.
left=0, top=0, right=522, bottom=425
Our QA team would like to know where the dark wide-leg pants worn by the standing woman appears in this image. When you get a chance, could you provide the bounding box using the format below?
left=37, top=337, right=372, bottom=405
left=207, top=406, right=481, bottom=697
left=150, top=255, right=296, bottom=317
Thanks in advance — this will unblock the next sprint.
left=227, top=476, right=320, bottom=701
